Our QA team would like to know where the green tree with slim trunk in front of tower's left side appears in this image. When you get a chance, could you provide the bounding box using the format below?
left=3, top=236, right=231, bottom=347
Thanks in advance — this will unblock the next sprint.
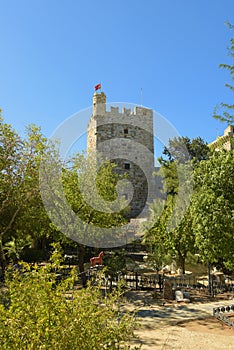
left=41, top=151, right=127, bottom=285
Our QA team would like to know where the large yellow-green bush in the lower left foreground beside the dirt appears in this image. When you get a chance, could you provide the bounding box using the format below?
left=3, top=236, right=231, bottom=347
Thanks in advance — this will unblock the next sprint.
left=0, top=265, right=139, bottom=350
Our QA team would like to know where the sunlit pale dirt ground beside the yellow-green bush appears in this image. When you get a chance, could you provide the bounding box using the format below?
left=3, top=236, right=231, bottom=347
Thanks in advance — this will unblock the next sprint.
left=125, top=291, right=234, bottom=350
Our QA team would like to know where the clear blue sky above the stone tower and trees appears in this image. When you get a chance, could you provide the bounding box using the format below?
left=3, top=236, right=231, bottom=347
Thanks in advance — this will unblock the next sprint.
left=0, top=0, right=234, bottom=153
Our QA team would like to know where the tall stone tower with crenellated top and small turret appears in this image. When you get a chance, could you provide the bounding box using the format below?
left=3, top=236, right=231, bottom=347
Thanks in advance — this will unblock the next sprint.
left=87, top=92, right=154, bottom=218
